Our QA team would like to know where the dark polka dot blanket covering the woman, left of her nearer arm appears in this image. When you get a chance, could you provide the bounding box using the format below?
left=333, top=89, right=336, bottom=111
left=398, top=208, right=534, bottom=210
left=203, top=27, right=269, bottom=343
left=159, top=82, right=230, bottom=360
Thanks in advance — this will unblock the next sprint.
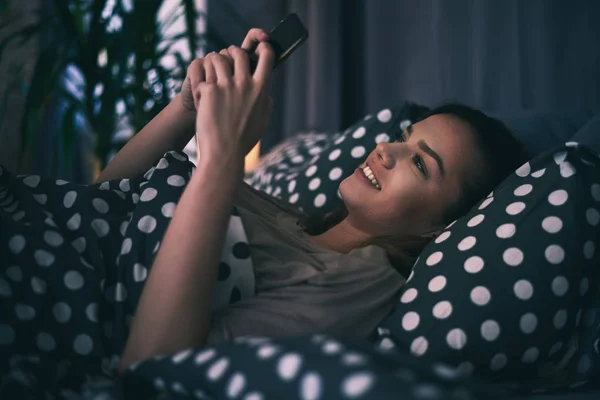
left=0, top=152, right=254, bottom=398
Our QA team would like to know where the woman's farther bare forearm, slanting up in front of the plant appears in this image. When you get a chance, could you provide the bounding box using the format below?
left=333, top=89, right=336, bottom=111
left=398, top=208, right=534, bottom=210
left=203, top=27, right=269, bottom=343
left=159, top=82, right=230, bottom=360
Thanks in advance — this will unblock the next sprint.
left=98, top=94, right=196, bottom=182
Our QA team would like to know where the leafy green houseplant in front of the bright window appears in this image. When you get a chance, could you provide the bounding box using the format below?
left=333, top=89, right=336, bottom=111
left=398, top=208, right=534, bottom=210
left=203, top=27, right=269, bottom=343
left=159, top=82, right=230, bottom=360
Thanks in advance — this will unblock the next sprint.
left=0, top=0, right=243, bottom=180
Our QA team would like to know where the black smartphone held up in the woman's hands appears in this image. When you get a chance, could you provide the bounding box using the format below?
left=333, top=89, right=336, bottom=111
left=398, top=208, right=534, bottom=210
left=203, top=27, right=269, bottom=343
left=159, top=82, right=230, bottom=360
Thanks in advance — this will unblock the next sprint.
left=248, top=13, right=308, bottom=74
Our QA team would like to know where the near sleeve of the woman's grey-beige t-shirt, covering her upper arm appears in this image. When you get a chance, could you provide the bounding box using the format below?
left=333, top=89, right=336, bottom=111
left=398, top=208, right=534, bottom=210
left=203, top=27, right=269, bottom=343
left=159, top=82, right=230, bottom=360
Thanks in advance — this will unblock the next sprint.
left=207, top=271, right=402, bottom=345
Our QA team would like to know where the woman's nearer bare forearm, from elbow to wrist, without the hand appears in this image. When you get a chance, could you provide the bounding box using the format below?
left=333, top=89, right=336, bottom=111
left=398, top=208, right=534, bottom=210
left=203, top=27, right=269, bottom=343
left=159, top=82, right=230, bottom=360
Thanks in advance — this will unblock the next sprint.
left=119, top=153, right=244, bottom=374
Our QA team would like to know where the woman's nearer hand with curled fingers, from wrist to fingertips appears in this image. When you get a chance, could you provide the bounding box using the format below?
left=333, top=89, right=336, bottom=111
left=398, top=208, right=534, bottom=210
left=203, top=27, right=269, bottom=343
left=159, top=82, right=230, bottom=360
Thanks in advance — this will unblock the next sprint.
left=194, top=42, right=275, bottom=166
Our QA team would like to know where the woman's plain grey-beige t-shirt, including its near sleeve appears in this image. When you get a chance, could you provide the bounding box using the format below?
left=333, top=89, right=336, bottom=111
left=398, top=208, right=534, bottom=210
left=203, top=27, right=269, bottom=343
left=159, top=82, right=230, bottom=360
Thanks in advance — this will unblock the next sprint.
left=208, top=183, right=405, bottom=345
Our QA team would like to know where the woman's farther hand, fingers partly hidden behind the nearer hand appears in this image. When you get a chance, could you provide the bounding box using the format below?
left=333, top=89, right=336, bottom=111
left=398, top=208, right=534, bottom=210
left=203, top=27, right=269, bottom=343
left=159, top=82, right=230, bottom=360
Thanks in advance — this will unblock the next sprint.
left=181, top=28, right=269, bottom=112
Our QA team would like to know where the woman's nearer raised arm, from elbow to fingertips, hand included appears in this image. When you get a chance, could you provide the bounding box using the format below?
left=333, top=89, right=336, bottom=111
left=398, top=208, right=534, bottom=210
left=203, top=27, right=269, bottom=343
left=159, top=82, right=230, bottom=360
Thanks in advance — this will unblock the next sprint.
left=119, top=43, right=275, bottom=373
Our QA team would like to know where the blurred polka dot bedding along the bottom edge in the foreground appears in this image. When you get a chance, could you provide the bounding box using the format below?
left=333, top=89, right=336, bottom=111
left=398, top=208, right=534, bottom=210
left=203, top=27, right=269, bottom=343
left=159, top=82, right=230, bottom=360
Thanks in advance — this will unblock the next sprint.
left=123, top=335, right=506, bottom=400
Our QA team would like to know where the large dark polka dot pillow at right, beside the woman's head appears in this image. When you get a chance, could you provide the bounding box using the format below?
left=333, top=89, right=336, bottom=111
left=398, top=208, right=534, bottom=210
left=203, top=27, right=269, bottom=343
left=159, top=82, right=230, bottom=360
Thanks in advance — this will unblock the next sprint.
left=379, top=142, right=600, bottom=388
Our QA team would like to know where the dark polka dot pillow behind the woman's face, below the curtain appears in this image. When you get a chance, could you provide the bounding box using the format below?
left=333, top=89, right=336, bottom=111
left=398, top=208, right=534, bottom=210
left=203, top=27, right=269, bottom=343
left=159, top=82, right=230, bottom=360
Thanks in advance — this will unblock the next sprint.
left=245, top=103, right=427, bottom=215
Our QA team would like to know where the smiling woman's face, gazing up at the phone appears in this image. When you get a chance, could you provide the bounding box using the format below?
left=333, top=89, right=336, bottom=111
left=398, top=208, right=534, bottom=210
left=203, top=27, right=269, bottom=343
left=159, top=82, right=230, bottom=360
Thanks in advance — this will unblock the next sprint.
left=339, top=114, right=482, bottom=236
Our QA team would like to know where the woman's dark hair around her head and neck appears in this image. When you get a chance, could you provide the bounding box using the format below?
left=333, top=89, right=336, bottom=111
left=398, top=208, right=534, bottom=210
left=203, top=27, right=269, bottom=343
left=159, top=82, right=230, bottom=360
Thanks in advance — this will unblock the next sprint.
left=299, top=103, right=529, bottom=276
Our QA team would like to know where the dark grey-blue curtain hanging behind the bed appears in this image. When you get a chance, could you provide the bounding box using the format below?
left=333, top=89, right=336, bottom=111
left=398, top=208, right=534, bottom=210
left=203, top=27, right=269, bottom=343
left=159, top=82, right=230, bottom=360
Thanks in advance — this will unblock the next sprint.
left=208, top=0, right=600, bottom=151
